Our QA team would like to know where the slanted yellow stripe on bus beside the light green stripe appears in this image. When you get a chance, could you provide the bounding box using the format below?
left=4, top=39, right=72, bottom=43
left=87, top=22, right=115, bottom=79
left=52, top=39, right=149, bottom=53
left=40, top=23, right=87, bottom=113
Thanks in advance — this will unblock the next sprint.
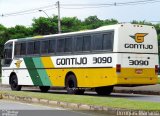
left=41, top=57, right=55, bottom=86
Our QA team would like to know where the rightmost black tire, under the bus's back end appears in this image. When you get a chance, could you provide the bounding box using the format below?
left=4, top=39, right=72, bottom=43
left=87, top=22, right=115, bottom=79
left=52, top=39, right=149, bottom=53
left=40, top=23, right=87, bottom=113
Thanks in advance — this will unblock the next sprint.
left=95, top=86, right=113, bottom=95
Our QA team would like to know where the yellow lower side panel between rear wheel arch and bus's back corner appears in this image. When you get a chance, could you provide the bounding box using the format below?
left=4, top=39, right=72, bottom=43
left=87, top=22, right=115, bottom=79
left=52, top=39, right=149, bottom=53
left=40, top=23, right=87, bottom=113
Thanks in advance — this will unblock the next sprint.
left=75, top=68, right=117, bottom=88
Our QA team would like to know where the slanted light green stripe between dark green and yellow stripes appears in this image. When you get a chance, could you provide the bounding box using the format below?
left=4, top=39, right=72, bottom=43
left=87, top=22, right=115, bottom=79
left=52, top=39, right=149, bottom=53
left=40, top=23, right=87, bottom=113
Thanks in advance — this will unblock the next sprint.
left=33, top=57, right=52, bottom=86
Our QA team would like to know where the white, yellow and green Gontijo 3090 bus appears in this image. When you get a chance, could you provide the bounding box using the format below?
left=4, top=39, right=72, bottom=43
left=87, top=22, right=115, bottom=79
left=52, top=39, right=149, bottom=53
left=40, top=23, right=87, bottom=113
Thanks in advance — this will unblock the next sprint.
left=1, top=23, right=158, bottom=95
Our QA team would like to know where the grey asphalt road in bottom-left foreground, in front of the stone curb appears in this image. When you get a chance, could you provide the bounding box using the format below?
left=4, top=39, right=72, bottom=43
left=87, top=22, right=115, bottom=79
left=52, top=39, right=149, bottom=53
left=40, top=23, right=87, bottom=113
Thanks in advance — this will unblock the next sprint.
left=0, top=100, right=111, bottom=116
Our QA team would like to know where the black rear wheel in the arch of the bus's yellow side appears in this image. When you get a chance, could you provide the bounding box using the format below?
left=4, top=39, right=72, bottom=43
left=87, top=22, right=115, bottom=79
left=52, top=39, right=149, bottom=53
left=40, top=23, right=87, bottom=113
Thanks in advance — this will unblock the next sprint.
left=65, top=74, right=85, bottom=95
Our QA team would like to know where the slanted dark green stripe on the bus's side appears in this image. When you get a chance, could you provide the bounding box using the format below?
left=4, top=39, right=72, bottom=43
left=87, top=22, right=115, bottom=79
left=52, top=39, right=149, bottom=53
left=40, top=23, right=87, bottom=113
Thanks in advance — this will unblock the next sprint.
left=24, top=57, right=43, bottom=86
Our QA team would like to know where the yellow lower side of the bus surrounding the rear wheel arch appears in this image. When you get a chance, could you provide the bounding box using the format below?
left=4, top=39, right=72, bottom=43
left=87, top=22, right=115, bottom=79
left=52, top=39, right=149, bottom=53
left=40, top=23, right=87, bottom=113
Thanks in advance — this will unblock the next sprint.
left=41, top=68, right=117, bottom=88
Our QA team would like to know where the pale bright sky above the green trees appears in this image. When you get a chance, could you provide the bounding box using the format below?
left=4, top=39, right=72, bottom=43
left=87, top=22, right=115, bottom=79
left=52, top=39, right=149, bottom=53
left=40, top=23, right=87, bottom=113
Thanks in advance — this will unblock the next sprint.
left=0, top=0, right=160, bottom=27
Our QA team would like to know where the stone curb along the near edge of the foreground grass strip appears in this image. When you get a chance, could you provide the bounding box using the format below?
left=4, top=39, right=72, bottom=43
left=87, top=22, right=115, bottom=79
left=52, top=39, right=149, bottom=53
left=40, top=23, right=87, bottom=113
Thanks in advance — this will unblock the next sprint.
left=0, top=93, right=160, bottom=116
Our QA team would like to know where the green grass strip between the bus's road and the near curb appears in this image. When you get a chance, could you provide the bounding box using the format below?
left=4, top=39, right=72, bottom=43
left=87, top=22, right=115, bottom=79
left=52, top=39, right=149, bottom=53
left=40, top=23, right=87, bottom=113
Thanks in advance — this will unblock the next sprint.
left=0, top=91, right=160, bottom=110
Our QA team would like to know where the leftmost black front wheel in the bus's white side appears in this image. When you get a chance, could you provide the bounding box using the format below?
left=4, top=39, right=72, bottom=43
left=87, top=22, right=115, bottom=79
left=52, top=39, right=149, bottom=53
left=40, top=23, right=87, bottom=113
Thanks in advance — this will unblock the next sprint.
left=10, top=75, right=22, bottom=91
